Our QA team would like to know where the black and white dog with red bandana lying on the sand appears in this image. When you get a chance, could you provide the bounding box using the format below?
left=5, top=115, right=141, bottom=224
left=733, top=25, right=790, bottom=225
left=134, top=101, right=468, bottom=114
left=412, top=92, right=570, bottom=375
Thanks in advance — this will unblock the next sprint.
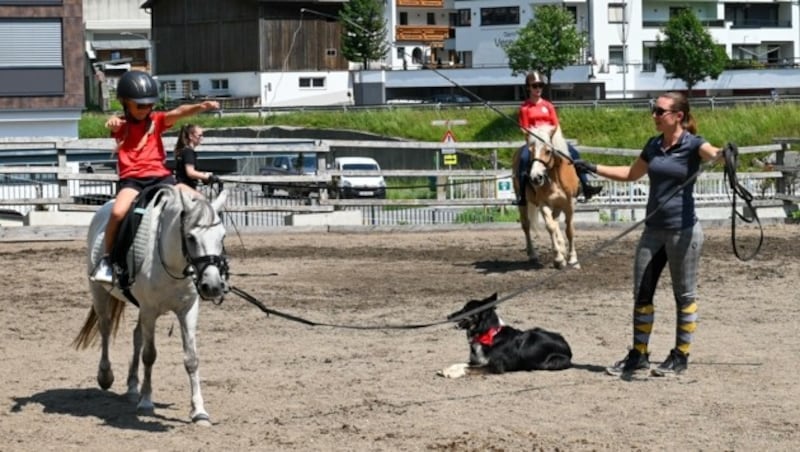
left=438, top=293, right=572, bottom=378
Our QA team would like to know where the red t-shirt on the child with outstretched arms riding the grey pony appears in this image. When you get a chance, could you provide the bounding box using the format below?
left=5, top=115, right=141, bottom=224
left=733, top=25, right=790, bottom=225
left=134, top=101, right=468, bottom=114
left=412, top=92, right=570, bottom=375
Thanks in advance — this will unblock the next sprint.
left=111, top=112, right=172, bottom=179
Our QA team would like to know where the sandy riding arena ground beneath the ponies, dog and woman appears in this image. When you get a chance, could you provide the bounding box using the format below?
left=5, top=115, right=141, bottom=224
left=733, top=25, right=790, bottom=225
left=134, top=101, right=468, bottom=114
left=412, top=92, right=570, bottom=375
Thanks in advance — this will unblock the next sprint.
left=0, top=225, right=800, bottom=451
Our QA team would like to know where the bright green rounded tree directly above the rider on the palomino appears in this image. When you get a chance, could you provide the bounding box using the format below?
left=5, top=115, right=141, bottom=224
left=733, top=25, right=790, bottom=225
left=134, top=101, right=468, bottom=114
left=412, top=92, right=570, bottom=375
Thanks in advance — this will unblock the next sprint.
left=503, top=5, right=586, bottom=96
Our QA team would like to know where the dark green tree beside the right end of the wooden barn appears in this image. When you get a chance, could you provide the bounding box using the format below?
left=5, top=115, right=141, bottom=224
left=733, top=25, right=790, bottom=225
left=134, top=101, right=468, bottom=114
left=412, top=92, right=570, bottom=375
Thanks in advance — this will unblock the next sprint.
left=339, top=0, right=389, bottom=69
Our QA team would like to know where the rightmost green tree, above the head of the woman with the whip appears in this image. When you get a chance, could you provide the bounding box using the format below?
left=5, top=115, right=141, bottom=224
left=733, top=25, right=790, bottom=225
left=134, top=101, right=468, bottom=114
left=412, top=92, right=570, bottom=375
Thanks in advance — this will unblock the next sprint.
left=656, top=8, right=728, bottom=96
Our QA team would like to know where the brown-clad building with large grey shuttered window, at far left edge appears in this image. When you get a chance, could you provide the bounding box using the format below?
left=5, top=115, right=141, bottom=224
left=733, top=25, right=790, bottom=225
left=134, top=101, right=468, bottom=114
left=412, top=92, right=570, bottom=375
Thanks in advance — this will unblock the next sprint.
left=0, top=0, right=86, bottom=138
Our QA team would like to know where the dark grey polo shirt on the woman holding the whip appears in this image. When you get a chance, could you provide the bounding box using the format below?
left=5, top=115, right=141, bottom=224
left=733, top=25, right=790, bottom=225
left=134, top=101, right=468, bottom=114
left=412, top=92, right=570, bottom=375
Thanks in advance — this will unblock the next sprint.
left=639, top=131, right=706, bottom=229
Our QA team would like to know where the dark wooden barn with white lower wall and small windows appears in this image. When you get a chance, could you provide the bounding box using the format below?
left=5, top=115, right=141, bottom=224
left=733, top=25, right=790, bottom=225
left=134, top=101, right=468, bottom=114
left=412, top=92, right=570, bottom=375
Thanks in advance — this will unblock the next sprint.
left=142, top=0, right=348, bottom=105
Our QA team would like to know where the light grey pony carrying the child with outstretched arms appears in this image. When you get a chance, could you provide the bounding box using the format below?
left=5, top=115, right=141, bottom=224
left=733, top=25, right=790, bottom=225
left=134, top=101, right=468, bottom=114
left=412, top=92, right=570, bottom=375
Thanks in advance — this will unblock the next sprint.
left=73, top=186, right=228, bottom=425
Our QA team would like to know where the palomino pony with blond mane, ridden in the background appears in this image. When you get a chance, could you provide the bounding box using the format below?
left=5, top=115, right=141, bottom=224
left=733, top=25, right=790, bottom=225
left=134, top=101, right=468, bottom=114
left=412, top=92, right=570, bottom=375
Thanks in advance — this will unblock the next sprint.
left=512, top=127, right=580, bottom=268
